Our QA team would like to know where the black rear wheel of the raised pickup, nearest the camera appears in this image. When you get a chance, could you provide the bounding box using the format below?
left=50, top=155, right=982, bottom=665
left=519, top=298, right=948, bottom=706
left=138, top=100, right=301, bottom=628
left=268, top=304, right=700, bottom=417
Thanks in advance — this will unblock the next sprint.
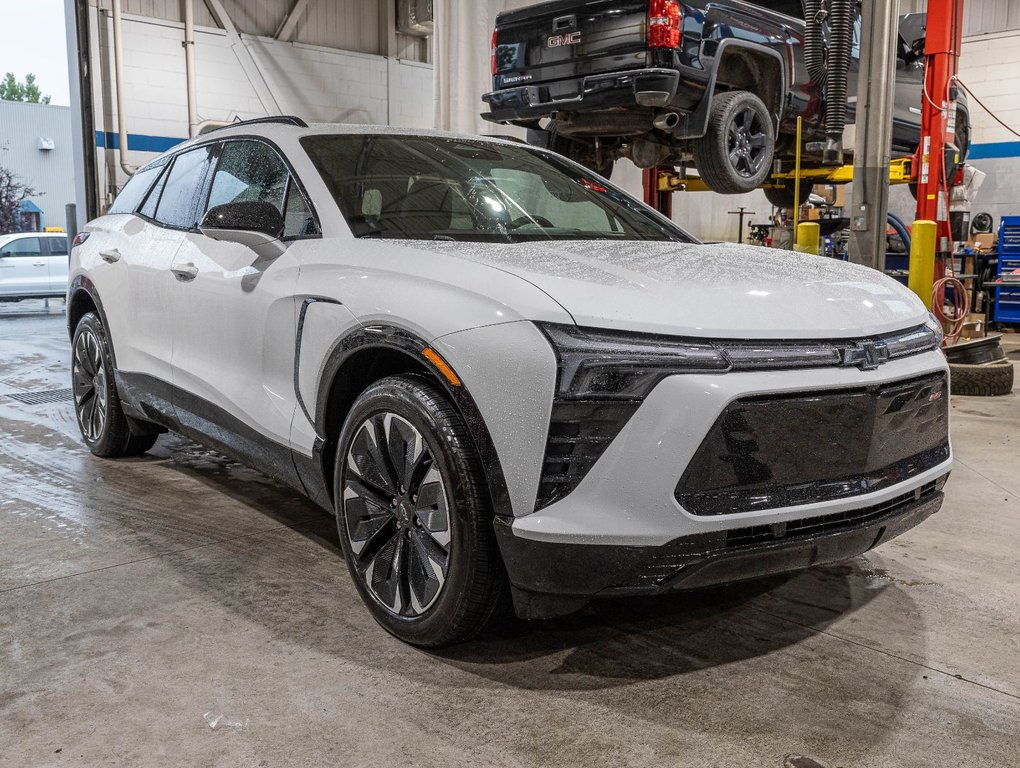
left=694, top=91, right=775, bottom=195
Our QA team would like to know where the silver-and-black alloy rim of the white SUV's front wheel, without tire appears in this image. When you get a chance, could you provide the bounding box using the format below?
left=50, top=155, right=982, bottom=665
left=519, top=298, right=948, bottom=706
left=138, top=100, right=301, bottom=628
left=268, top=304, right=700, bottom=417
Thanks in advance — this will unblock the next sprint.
left=341, top=412, right=453, bottom=618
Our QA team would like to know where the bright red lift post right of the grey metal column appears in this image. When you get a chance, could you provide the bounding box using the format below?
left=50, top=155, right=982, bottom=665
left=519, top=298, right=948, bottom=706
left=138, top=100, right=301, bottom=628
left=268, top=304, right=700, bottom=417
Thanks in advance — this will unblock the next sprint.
left=914, top=0, right=963, bottom=273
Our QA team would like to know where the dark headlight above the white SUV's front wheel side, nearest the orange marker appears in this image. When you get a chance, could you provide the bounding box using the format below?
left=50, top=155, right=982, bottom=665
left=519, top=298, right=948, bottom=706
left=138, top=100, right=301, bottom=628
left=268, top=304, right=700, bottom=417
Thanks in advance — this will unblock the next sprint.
left=539, top=323, right=729, bottom=400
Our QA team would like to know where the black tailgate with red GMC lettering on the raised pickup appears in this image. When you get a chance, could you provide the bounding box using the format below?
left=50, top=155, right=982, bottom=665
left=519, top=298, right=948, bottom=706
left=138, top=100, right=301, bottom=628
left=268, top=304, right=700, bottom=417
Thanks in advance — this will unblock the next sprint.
left=493, top=0, right=649, bottom=99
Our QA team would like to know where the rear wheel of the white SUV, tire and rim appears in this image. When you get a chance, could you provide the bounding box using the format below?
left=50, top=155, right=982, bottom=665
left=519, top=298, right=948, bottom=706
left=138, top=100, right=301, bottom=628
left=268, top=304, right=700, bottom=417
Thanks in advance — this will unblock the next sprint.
left=71, top=312, right=157, bottom=458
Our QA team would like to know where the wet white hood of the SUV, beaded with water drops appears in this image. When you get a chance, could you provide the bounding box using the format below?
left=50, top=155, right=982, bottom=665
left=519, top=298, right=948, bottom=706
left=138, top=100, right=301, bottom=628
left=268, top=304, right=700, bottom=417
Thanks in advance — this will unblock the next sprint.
left=405, top=241, right=927, bottom=339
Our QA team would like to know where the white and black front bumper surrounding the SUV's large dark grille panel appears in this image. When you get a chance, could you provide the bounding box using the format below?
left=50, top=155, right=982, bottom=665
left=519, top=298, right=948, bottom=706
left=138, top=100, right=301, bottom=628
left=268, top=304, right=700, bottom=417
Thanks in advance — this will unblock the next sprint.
left=496, top=352, right=953, bottom=618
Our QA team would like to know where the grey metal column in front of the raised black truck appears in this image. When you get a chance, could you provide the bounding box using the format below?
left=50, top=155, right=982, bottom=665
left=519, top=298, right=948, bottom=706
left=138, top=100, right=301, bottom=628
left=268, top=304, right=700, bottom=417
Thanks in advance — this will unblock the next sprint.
left=850, top=0, right=899, bottom=269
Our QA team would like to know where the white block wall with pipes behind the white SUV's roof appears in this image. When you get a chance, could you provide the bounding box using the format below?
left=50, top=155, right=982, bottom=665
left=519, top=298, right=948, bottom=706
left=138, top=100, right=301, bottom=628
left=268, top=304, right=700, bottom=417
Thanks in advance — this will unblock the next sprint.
left=90, top=8, right=434, bottom=210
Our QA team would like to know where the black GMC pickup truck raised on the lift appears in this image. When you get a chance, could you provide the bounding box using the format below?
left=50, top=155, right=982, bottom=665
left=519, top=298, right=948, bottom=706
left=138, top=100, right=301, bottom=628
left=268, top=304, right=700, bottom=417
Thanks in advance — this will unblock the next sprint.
left=482, top=0, right=969, bottom=206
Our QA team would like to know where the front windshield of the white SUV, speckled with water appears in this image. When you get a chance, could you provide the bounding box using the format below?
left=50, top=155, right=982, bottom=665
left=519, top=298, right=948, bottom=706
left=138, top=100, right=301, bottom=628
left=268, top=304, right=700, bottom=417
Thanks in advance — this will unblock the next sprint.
left=301, top=135, right=693, bottom=242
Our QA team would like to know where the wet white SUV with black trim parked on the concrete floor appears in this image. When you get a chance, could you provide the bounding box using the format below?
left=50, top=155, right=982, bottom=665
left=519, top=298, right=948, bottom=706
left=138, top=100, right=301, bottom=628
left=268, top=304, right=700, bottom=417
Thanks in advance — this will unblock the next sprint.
left=68, top=118, right=952, bottom=646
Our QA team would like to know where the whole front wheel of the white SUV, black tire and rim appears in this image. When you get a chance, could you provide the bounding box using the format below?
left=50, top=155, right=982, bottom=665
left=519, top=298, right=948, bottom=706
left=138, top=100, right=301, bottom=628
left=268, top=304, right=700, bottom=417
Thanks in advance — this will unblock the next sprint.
left=334, top=376, right=508, bottom=648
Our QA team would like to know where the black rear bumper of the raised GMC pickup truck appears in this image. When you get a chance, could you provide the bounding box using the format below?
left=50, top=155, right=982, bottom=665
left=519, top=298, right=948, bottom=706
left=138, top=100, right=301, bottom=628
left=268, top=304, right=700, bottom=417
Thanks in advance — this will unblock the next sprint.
left=481, top=68, right=680, bottom=122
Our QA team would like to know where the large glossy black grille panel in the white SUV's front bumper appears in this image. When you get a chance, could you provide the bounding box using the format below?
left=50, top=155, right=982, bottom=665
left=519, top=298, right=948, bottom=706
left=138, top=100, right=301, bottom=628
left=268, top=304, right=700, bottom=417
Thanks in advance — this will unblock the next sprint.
left=675, top=374, right=950, bottom=515
